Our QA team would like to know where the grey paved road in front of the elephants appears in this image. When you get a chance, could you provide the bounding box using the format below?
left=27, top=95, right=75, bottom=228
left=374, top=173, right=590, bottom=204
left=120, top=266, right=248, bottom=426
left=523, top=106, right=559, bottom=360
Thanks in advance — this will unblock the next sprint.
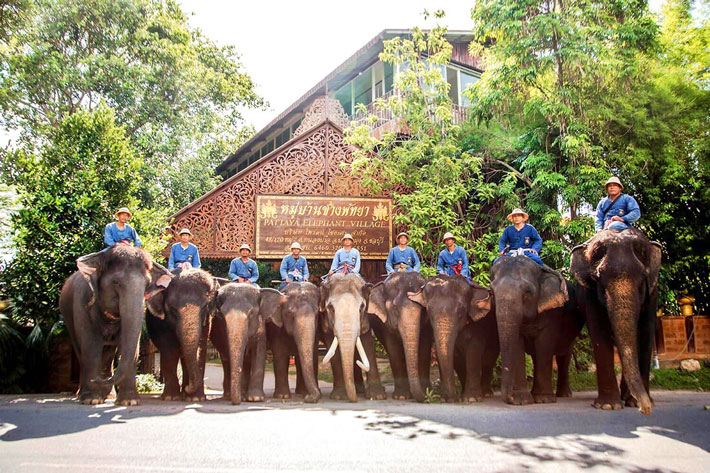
left=0, top=392, right=710, bottom=473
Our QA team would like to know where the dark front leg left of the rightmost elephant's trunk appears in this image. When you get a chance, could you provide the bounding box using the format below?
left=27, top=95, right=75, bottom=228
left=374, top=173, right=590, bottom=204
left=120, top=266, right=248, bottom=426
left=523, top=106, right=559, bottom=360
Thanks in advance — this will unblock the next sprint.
left=586, top=302, right=624, bottom=410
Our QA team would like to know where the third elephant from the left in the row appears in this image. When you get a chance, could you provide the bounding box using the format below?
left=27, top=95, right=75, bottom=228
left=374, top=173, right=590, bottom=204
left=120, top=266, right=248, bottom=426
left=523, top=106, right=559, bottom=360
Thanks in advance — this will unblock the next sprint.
left=210, top=282, right=284, bottom=405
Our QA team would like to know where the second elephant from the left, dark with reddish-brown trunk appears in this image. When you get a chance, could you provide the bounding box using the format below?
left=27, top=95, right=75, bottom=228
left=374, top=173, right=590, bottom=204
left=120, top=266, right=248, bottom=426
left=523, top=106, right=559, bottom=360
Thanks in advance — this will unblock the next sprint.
left=146, top=268, right=219, bottom=402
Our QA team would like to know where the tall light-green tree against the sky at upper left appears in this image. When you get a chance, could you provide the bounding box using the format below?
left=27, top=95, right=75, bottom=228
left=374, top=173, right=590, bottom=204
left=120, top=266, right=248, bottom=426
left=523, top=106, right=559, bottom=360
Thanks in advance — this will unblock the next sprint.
left=0, top=0, right=263, bottom=210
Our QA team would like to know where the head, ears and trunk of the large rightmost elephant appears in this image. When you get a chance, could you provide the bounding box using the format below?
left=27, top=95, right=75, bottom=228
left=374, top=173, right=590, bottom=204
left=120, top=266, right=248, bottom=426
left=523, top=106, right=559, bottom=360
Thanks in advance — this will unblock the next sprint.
left=570, top=229, right=661, bottom=414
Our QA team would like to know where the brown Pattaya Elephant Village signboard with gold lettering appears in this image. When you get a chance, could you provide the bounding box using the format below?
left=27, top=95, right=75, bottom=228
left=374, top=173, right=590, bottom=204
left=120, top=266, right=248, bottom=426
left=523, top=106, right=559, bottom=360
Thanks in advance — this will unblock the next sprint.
left=256, top=195, right=392, bottom=259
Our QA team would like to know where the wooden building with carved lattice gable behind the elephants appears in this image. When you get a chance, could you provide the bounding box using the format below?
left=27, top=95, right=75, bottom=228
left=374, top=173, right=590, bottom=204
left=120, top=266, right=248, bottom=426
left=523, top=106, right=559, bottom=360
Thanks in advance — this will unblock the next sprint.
left=171, top=30, right=481, bottom=280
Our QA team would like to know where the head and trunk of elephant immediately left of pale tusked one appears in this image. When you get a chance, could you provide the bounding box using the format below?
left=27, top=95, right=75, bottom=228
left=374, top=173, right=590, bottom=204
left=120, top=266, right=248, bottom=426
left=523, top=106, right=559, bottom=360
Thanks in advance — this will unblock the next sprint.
left=261, top=282, right=320, bottom=402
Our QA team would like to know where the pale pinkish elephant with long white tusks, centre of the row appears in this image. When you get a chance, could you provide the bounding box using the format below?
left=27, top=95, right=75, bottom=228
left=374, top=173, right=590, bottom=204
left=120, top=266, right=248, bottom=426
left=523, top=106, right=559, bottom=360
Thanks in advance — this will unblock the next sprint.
left=319, top=273, right=384, bottom=402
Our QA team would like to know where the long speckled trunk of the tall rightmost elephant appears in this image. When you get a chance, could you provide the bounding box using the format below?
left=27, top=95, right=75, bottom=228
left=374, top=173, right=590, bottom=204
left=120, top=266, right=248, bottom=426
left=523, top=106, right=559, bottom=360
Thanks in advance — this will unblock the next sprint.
left=606, top=279, right=653, bottom=415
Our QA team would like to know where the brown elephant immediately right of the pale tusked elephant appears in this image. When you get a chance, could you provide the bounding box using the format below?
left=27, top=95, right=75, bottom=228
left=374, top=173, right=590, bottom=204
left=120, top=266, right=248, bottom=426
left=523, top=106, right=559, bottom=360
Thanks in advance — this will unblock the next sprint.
left=367, top=272, right=433, bottom=402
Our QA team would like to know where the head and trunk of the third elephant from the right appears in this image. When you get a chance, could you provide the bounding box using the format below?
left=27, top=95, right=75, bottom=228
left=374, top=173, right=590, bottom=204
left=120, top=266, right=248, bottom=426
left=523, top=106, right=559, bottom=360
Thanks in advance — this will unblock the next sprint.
left=408, top=274, right=491, bottom=402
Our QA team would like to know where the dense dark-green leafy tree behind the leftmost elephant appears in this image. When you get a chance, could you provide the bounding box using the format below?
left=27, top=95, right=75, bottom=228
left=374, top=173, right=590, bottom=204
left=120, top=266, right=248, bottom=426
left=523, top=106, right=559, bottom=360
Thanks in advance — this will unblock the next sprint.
left=0, top=107, right=140, bottom=330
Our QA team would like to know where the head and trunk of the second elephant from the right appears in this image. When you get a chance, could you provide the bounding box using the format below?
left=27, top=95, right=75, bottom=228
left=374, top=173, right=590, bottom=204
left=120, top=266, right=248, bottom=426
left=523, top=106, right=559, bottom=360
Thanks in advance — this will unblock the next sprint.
left=491, top=256, right=569, bottom=404
